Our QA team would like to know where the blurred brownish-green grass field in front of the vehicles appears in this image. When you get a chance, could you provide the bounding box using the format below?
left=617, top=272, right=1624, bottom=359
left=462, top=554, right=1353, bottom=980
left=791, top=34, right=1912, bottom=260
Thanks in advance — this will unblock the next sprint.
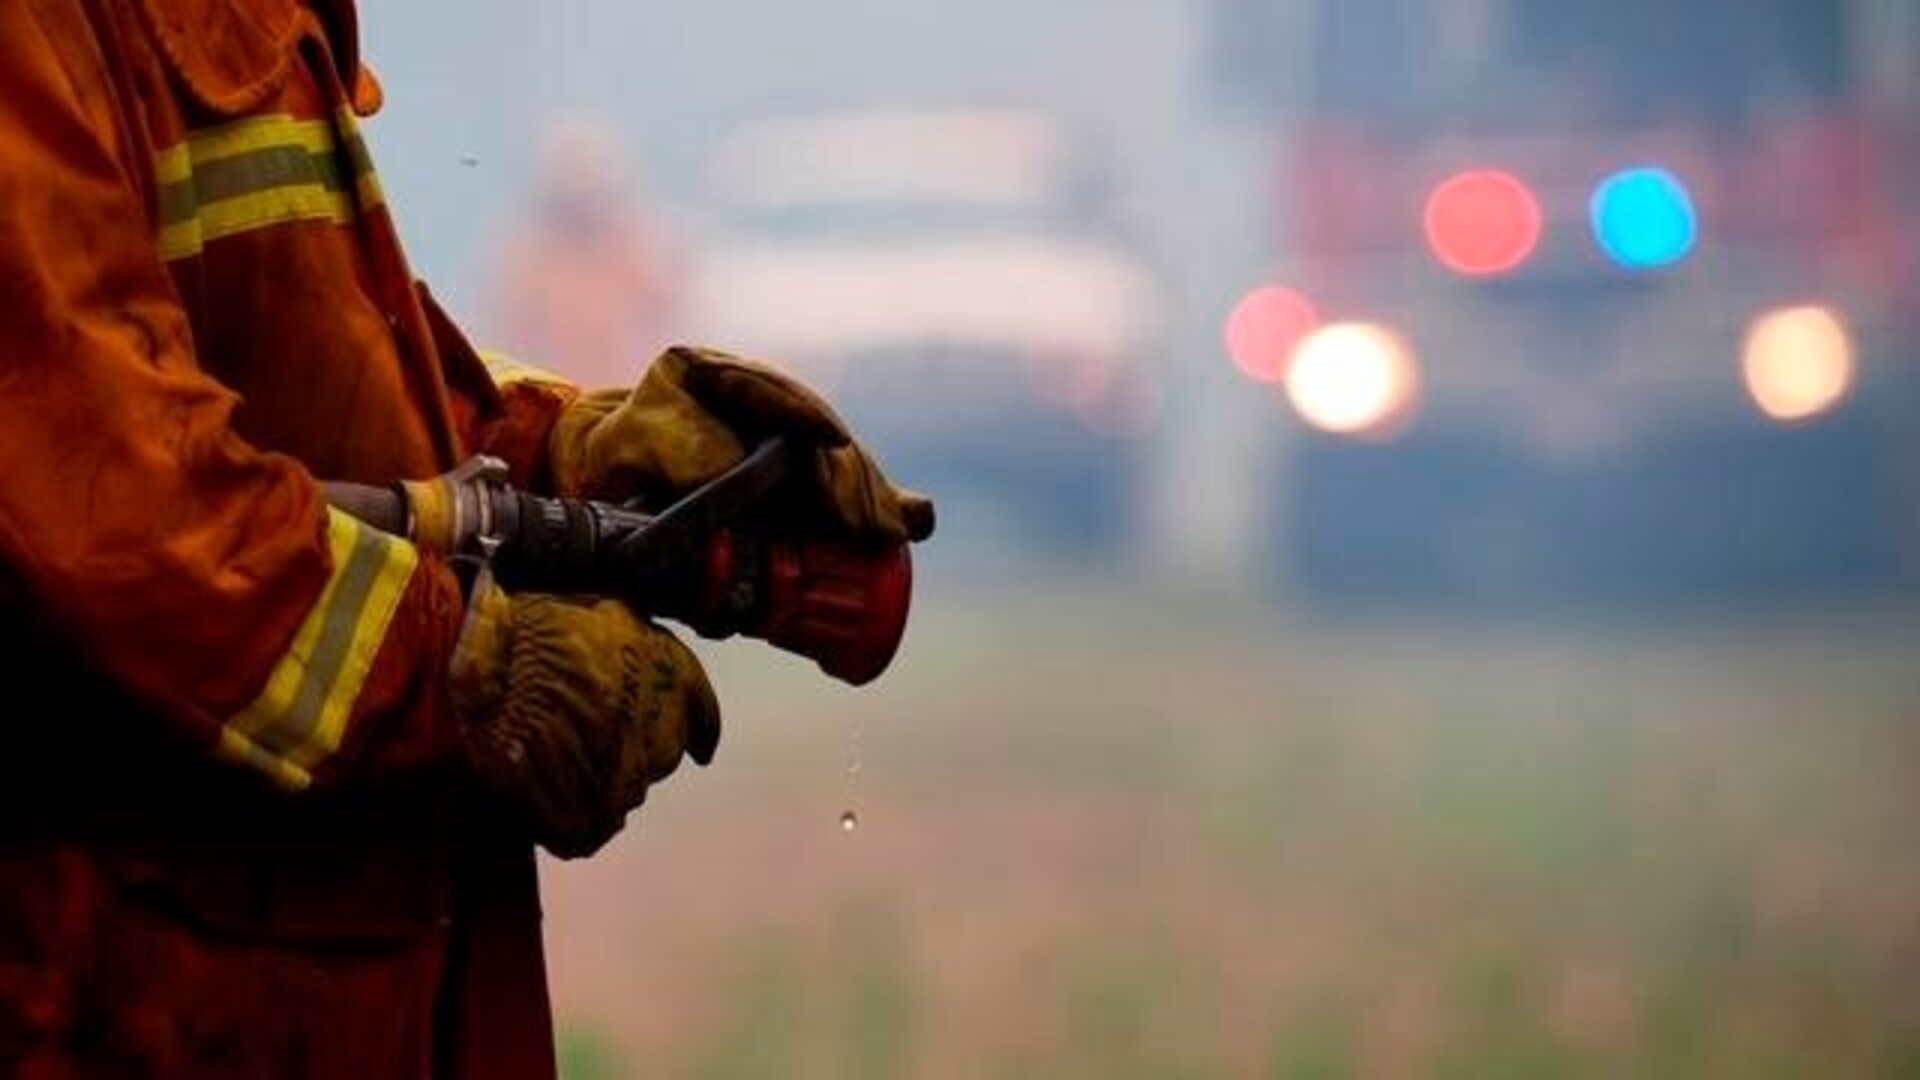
left=547, top=582, right=1920, bottom=1080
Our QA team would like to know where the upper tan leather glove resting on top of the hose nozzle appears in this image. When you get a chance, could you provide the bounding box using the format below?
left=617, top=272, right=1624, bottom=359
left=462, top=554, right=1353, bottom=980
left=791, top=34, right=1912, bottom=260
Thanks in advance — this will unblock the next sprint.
left=547, top=346, right=933, bottom=544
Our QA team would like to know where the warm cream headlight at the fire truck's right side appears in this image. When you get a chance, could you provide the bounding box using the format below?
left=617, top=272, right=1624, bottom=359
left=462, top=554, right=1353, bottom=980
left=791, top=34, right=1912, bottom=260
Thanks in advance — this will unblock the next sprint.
left=1741, top=306, right=1853, bottom=423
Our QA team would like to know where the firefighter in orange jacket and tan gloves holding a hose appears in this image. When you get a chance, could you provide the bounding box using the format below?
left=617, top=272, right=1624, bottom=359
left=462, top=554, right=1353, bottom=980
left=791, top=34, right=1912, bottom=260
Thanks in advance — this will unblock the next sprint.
left=0, top=0, right=931, bottom=1080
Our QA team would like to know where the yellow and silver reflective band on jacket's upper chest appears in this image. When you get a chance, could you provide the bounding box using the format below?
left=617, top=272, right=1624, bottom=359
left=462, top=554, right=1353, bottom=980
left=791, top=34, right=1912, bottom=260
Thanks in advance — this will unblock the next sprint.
left=154, top=113, right=384, bottom=261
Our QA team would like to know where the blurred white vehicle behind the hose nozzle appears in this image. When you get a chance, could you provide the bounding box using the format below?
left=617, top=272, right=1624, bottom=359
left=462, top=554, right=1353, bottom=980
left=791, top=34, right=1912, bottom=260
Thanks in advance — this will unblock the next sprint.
left=689, top=108, right=1160, bottom=557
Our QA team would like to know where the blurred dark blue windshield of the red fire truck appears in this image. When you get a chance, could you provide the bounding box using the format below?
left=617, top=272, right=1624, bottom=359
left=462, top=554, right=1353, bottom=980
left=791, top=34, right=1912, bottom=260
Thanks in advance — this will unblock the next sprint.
left=1311, top=0, right=1849, bottom=127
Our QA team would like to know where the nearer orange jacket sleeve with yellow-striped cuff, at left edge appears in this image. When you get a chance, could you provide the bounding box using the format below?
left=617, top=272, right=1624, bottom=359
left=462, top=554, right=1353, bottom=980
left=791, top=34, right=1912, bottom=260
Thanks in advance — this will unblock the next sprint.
left=0, top=4, right=461, bottom=790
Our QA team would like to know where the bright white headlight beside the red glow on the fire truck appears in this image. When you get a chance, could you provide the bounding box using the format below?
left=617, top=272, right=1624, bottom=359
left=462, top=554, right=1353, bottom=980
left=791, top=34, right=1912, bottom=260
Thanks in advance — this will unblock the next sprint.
left=1286, top=323, right=1421, bottom=438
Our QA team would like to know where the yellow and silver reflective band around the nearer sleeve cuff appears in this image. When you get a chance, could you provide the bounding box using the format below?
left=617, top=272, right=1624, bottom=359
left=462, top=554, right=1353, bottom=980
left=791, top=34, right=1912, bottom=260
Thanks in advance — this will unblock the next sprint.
left=219, top=509, right=419, bottom=792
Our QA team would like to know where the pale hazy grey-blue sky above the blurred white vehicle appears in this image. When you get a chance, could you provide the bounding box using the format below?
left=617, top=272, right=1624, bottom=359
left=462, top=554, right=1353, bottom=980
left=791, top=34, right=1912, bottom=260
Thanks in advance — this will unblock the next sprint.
left=363, top=0, right=1198, bottom=311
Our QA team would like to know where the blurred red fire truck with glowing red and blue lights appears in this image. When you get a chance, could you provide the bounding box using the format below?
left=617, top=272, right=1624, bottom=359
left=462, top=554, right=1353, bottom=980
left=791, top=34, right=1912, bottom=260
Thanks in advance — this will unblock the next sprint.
left=1225, top=0, right=1920, bottom=611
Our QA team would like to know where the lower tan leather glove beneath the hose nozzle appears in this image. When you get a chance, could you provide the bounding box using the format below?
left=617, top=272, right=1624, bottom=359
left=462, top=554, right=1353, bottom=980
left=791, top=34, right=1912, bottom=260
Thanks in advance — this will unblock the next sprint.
left=449, top=577, right=720, bottom=859
